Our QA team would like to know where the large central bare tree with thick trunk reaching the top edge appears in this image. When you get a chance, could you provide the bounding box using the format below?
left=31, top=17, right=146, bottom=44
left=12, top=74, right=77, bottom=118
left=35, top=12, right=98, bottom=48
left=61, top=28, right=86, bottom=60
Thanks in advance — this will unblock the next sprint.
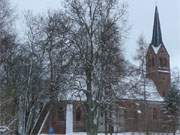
left=67, top=0, right=126, bottom=135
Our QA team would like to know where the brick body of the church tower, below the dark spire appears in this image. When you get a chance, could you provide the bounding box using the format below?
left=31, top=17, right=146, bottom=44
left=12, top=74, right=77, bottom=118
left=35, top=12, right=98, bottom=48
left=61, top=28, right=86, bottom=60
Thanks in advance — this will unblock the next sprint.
left=146, top=46, right=171, bottom=97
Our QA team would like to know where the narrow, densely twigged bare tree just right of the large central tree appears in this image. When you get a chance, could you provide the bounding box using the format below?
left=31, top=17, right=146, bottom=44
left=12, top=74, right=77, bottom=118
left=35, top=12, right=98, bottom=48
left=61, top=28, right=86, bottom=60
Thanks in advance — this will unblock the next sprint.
left=94, top=20, right=124, bottom=133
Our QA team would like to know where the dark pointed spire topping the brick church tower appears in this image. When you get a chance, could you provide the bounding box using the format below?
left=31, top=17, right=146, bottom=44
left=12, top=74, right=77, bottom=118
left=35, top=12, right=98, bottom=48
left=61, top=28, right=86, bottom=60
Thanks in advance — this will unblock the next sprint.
left=151, top=6, right=163, bottom=47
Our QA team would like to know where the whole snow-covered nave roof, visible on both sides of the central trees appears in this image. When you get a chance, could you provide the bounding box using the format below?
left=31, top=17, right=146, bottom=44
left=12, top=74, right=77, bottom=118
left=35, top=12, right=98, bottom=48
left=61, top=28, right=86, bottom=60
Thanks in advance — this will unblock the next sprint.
left=59, top=70, right=164, bottom=102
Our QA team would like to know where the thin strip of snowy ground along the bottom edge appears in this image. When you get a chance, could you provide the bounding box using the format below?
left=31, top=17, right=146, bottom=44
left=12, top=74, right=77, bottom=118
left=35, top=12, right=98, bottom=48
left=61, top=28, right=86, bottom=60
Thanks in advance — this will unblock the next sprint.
left=41, top=132, right=180, bottom=135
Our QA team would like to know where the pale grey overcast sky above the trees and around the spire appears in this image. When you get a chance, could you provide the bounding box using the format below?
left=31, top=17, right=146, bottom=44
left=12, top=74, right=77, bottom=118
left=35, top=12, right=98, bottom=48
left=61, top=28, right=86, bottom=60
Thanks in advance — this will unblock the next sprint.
left=11, top=0, right=180, bottom=69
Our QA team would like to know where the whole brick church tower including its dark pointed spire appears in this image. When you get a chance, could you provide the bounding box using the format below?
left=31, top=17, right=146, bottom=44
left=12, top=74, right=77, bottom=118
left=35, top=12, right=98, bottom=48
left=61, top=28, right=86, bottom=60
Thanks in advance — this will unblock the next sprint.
left=146, top=6, right=171, bottom=97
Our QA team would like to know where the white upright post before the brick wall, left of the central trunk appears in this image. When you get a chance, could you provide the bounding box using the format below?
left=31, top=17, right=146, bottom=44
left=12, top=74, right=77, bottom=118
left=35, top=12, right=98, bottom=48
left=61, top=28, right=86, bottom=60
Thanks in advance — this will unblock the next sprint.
left=66, top=104, right=73, bottom=135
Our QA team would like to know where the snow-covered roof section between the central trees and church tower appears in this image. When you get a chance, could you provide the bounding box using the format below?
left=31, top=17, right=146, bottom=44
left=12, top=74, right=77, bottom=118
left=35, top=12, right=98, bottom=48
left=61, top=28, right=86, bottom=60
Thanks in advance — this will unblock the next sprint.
left=119, top=76, right=164, bottom=102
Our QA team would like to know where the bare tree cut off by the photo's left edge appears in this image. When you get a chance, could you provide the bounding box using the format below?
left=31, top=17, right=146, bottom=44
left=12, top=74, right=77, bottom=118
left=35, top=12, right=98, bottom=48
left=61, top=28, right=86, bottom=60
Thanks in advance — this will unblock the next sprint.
left=0, top=0, right=16, bottom=134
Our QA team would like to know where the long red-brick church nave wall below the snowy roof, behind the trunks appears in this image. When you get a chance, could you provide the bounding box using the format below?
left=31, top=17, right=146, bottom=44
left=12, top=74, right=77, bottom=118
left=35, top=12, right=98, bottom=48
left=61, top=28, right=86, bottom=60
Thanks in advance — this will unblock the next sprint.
left=38, top=100, right=172, bottom=134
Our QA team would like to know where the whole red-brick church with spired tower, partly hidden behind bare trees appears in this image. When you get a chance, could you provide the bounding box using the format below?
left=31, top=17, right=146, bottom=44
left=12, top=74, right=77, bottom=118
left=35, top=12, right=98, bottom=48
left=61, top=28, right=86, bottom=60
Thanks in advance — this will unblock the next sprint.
left=31, top=6, right=171, bottom=135
